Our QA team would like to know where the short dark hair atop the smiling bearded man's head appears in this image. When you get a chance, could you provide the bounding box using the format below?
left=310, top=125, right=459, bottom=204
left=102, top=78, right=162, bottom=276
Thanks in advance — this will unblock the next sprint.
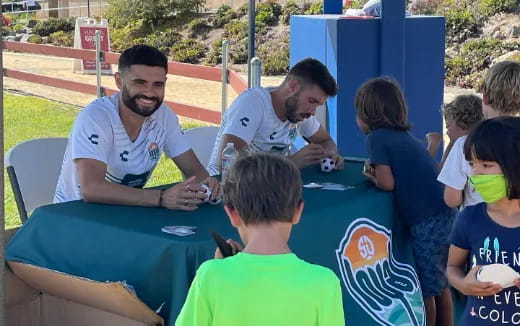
left=118, top=45, right=168, bottom=72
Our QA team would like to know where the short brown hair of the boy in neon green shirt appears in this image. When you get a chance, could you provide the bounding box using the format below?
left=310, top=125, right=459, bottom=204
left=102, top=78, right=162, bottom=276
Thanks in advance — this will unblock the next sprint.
left=223, top=153, right=302, bottom=225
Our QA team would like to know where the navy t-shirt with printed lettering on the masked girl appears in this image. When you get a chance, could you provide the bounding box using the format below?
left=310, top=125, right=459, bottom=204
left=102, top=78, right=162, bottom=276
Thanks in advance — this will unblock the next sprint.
left=450, top=203, right=520, bottom=326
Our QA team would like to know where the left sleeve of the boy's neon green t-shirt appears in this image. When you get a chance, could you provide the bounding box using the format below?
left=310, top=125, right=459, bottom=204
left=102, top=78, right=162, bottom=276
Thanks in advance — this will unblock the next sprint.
left=175, top=264, right=212, bottom=326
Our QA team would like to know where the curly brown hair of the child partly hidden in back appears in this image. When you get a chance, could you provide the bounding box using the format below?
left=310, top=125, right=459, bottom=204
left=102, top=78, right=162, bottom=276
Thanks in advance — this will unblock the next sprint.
left=442, top=94, right=484, bottom=130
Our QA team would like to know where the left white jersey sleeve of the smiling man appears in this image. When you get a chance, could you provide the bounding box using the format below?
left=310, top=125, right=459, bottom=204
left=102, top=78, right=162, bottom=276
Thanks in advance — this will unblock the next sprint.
left=70, top=107, right=114, bottom=164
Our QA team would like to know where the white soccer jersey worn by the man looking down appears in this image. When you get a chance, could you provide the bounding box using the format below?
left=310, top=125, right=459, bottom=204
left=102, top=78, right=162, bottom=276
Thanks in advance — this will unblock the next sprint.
left=207, top=87, right=320, bottom=175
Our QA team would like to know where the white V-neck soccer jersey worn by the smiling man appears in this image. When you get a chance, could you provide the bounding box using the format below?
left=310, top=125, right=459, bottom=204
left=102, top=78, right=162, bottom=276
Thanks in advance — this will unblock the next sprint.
left=54, top=93, right=191, bottom=203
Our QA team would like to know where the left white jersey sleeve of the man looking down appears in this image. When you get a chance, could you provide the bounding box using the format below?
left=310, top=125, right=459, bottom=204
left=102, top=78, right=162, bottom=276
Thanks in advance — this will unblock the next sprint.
left=222, top=96, right=264, bottom=144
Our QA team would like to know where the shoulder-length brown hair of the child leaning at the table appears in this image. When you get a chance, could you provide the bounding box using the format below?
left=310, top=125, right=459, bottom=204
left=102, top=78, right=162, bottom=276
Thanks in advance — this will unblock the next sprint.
left=354, top=78, right=411, bottom=131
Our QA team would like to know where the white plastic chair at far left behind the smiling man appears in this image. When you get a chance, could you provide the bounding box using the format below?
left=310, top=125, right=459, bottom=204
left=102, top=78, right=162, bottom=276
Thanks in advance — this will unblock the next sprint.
left=5, top=138, right=68, bottom=223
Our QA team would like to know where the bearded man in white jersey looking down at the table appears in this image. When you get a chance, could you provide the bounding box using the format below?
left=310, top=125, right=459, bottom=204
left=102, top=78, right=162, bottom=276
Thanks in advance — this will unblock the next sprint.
left=207, top=58, right=343, bottom=175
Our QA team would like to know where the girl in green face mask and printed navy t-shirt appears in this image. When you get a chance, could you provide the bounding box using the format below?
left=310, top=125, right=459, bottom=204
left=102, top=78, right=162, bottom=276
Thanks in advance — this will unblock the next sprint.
left=447, top=117, right=520, bottom=326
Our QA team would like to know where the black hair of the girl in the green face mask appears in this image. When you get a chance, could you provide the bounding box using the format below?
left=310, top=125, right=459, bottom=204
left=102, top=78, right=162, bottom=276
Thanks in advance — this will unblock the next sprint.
left=464, top=117, right=520, bottom=199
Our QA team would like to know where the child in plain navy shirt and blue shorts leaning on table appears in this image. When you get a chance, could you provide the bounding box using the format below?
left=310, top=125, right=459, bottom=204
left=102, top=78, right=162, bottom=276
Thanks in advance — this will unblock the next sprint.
left=355, top=78, right=455, bottom=326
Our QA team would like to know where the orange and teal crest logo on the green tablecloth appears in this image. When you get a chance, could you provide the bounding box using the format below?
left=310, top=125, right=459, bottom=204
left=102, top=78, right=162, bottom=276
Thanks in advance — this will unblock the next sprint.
left=336, top=218, right=426, bottom=326
